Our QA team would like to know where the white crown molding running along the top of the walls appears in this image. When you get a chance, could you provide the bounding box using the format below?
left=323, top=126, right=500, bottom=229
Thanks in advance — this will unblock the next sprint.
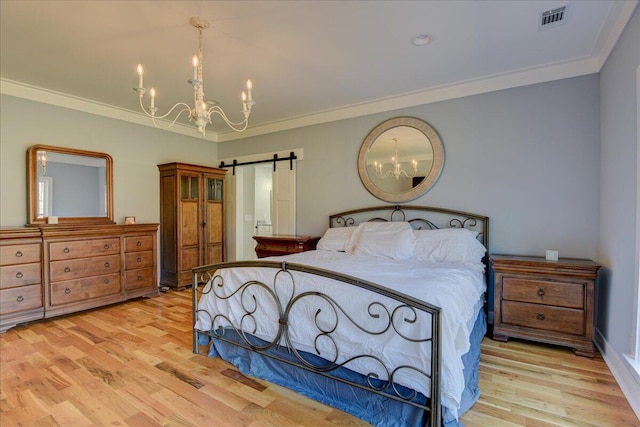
left=0, top=25, right=620, bottom=142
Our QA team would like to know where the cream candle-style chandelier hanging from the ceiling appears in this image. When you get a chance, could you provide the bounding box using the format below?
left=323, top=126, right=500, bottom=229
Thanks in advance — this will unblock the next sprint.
left=133, top=16, right=255, bottom=136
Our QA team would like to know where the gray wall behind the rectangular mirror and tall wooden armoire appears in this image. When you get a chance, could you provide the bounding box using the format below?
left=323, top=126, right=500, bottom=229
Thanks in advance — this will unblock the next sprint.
left=0, top=95, right=218, bottom=227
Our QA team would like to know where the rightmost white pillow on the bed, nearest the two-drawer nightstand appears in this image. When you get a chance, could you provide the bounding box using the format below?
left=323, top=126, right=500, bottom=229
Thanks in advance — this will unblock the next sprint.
left=413, top=228, right=487, bottom=265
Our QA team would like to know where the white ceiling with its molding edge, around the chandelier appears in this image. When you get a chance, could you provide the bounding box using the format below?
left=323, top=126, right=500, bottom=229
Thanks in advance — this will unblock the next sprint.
left=0, top=0, right=637, bottom=141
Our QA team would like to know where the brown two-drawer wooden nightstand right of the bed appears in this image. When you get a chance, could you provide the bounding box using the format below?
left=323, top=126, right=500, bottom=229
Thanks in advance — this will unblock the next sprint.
left=490, top=255, right=600, bottom=357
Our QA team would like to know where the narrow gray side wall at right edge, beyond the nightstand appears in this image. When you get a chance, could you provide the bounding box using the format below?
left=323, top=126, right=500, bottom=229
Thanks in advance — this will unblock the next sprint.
left=596, top=4, right=640, bottom=413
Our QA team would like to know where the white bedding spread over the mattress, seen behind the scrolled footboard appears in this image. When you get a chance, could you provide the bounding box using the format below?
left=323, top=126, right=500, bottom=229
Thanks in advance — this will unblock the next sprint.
left=196, top=250, right=486, bottom=415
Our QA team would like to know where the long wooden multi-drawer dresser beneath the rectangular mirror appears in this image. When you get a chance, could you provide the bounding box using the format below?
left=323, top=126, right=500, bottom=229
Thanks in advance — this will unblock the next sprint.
left=0, top=224, right=158, bottom=332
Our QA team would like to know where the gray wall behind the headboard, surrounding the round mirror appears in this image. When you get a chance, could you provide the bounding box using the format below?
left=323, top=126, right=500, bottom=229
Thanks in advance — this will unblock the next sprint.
left=218, top=75, right=600, bottom=259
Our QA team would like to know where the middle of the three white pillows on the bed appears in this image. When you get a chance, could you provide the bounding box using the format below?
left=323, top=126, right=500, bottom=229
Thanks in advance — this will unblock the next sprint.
left=345, top=222, right=414, bottom=259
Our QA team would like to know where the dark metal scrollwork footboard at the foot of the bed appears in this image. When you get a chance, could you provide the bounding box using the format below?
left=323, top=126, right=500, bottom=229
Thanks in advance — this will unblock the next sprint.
left=193, top=261, right=442, bottom=426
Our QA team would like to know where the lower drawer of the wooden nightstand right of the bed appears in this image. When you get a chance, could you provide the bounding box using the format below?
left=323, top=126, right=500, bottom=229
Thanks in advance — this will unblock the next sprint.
left=501, top=301, right=585, bottom=335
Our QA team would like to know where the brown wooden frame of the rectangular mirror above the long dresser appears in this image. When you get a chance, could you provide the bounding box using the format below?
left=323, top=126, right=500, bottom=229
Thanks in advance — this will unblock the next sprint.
left=27, top=145, right=114, bottom=226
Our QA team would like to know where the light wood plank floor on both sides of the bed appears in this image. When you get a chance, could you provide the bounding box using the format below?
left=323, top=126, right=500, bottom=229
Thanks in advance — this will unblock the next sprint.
left=0, top=291, right=640, bottom=427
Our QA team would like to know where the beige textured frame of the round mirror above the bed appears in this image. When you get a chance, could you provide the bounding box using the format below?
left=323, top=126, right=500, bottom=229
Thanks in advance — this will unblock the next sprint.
left=358, top=117, right=444, bottom=203
